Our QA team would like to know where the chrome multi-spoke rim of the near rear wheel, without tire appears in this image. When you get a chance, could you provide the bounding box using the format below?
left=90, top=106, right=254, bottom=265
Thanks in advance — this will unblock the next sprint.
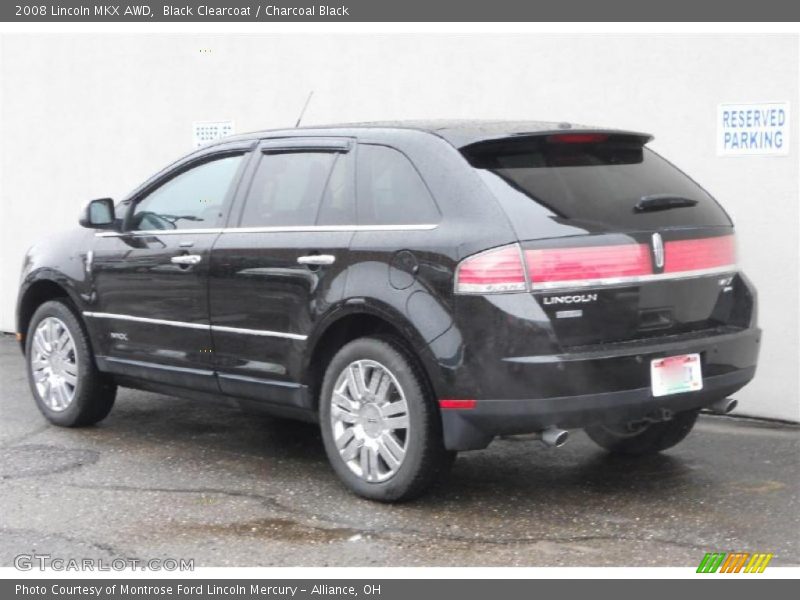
left=331, top=360, right=409, bottom=483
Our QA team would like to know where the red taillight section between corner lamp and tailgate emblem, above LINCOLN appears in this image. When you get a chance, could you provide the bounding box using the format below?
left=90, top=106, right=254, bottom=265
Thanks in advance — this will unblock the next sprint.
left=525, top=244, right=652, bottom=290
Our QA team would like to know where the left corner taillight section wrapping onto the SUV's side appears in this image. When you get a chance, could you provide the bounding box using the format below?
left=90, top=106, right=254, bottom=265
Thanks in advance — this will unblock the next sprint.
left=456, top=244, right=528, bottom=294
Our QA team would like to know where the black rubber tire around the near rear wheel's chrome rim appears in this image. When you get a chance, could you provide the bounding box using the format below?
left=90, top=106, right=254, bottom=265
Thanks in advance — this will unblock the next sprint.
left=319, top=337, right=456, bottom=502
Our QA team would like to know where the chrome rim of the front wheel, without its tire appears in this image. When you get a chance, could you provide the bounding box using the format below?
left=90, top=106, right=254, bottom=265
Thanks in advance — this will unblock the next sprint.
left=30, top=317, right=78, bottom=412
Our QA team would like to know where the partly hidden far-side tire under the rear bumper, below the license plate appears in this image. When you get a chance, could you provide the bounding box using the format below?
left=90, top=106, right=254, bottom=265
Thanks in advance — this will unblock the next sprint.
left=586, top=410, right=699, bottom=455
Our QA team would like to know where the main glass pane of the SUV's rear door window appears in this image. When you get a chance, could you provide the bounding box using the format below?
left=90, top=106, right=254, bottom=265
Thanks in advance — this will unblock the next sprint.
left=241, top=152, right=338, bottom=227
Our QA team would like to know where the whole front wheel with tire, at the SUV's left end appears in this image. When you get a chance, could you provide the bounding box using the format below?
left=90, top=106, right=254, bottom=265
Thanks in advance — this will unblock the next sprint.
left=25, top=300, right=117, bottom=427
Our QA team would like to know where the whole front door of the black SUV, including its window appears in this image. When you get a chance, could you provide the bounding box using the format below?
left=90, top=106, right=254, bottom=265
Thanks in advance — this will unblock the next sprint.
left=85, top=150, right=245, bottom=391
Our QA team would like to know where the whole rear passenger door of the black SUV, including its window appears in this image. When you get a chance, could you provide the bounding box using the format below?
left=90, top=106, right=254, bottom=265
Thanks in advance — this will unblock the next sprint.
left=209, top=138, right=355, bottom=407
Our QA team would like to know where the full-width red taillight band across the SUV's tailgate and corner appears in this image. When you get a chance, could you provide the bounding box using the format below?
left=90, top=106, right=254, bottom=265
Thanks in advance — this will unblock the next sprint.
left=455, top=235, right=736, bottom=294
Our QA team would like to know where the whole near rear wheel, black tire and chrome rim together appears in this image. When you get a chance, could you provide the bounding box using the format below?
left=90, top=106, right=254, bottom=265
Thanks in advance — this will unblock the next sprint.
left=320, top=338, right=455, bottom=502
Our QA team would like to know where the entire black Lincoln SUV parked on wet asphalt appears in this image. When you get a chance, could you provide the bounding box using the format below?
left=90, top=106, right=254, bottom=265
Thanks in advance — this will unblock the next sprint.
left=18, top=122, right=760, bottom=501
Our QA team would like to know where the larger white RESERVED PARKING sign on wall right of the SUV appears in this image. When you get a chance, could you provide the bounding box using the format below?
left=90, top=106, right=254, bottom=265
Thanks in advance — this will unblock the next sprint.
left=717, top=102, right=789, bottom=156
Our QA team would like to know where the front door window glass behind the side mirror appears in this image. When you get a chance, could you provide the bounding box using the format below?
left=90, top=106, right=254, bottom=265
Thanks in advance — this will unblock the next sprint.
left=128, top=155, right=244, bottom=231
